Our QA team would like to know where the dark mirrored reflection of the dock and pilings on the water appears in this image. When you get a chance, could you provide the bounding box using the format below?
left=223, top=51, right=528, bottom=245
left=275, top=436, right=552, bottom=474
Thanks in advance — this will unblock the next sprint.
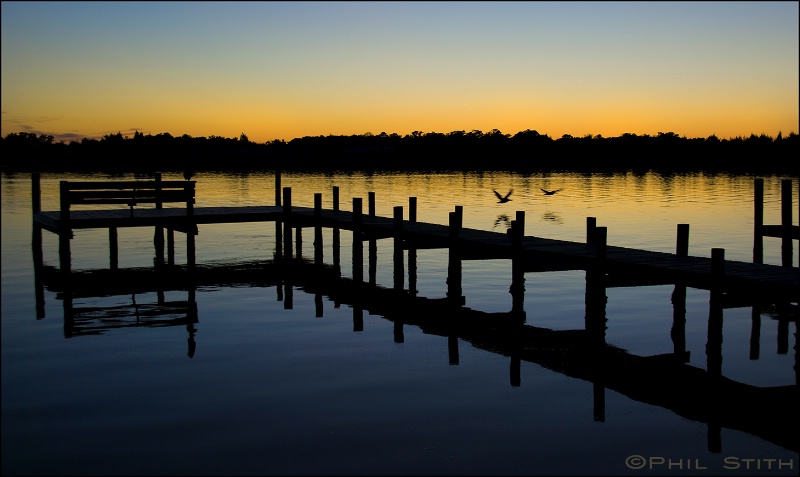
left=34, top=215, right=800, bottom=453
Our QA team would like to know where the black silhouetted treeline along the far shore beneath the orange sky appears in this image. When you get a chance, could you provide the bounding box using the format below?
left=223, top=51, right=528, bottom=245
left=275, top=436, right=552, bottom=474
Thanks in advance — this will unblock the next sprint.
left=0, top=129, right=800, bottom=175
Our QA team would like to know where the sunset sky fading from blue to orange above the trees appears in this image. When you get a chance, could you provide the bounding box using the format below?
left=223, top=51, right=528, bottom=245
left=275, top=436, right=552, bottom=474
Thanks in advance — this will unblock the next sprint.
left=1, top=1, right=800, bottom=142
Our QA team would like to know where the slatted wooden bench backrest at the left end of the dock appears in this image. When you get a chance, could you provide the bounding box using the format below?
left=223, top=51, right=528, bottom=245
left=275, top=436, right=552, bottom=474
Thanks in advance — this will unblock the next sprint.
left=61, top=180, right=195, bottom=219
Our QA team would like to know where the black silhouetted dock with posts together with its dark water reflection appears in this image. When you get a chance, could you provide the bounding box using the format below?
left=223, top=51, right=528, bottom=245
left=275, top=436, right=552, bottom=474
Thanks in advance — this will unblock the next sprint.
left=28, top=175, right=800, bottom=452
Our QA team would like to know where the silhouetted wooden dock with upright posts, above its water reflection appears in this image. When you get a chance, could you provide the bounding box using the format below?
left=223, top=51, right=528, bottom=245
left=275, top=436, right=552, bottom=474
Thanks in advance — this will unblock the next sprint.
left=33, top=173, right=800, bottom=303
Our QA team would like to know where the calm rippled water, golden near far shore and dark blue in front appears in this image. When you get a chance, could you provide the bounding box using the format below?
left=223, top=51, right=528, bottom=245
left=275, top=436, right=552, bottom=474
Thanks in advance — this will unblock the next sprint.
left=0, top=173, right=800, bottom=475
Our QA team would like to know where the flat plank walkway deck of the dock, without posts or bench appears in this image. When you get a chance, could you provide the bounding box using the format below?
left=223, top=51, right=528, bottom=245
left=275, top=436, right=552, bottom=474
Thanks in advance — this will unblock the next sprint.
left=33, top=202, right=800, bottom=301
